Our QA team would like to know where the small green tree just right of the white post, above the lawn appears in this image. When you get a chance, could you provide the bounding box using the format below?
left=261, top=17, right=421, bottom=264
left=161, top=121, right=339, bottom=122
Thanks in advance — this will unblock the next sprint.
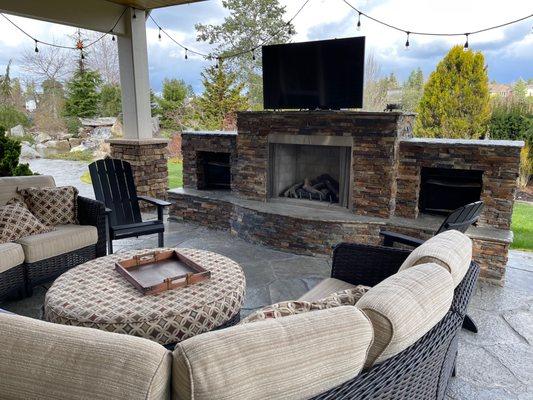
left=156, top=79, right=194, bottom=129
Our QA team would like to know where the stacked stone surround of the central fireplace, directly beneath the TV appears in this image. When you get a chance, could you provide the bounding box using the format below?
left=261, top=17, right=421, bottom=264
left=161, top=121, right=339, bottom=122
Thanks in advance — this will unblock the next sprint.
left=232, top=111, right=414, bottom=217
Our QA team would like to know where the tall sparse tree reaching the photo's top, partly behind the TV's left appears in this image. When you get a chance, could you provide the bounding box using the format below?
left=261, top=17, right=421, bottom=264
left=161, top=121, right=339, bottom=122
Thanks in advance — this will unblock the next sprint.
left=196, top=0, right=295, bottom=109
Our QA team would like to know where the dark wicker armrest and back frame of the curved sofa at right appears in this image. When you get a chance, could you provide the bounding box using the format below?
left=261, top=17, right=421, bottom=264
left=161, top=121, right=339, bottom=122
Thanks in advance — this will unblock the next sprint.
left=314, top=244, right=479, bottom=400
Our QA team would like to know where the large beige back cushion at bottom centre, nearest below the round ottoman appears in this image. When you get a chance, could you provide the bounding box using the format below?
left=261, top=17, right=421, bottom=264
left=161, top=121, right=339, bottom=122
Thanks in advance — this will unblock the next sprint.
left=172, top=306, right=372, bottom=400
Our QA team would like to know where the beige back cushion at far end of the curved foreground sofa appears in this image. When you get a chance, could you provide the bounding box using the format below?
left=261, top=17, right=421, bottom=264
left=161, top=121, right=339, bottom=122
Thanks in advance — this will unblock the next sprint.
left=400, top=230, right=472, bottom=286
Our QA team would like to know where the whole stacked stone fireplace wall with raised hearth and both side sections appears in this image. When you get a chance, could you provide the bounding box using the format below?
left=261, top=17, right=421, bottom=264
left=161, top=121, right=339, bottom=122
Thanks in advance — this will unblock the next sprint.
left=170, top=111, right=523, bottom=282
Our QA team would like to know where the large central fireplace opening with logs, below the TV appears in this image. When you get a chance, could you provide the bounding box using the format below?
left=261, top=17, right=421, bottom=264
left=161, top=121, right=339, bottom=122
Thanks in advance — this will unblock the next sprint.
left=270, top=143, right=351, bottom=207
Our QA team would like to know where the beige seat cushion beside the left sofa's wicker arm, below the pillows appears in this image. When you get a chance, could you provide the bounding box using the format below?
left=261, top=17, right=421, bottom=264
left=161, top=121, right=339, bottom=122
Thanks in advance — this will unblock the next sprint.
left=17, top=224, right=98, bottom=263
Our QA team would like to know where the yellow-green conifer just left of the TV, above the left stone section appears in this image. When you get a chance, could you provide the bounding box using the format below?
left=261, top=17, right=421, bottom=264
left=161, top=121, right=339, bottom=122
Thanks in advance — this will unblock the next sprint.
left=197, top=62, right=249, bottom=130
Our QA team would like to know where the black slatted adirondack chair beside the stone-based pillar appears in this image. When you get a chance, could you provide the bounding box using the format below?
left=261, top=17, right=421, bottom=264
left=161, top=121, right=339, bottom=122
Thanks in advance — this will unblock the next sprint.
left=89, top=158, right=170, bottom=254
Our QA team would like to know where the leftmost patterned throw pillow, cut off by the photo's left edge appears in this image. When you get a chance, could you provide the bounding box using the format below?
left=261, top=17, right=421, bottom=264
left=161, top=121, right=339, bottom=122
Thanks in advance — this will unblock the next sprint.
left=0, top=204, right=54, bottom=243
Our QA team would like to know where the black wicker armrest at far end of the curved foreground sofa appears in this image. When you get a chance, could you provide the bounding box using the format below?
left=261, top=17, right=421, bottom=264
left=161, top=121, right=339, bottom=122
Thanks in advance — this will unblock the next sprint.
left=331, top=243, right=411, bottom=286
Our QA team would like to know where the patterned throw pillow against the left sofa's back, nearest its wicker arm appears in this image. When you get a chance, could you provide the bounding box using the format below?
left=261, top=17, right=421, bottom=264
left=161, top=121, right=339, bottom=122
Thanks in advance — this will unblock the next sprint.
left=19, top=186, right=78, bottom=226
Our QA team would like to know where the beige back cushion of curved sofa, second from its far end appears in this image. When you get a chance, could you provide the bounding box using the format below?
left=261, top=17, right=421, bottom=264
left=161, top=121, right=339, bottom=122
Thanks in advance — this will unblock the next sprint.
left=356, top=264, right=454, bottom=367
